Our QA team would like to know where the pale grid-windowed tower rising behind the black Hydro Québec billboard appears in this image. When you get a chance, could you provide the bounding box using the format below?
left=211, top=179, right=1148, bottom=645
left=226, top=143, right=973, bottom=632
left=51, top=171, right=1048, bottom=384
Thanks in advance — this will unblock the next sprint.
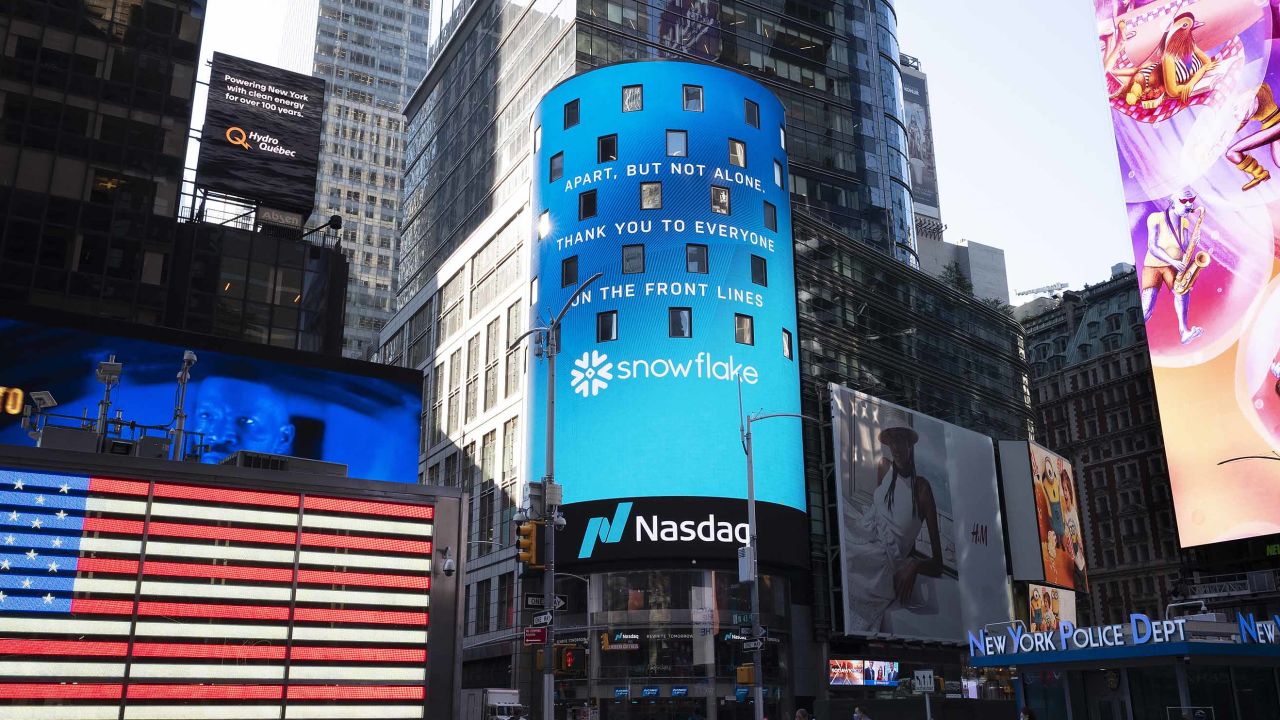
left=284, top=0, right=429, bottom=357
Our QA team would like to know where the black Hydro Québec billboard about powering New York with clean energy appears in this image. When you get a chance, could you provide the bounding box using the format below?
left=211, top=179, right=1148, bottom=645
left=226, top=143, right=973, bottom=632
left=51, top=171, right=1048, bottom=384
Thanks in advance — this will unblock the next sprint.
left=196, top=53, right=324, bottom=215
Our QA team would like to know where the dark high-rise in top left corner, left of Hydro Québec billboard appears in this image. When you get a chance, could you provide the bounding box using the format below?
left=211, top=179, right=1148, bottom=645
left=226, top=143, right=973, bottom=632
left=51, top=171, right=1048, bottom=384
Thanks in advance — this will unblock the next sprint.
left=0, top=0, right=205, bottom=323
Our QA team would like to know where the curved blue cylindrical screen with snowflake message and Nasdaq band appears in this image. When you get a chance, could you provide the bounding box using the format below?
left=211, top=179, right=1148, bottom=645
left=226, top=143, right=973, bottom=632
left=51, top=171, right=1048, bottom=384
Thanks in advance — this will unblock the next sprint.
left=527, top=61, right=809, bottom=566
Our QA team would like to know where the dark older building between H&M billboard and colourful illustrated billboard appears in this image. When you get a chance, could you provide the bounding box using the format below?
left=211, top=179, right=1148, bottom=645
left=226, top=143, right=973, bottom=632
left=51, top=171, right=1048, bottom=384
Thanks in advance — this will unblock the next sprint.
left=1023, top=265, right=1181, bottom=625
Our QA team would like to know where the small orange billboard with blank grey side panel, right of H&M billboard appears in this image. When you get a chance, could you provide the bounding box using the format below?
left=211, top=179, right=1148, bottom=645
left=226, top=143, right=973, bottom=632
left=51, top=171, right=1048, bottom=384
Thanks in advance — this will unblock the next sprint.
left=1000, top=441, right=1088, bottom=592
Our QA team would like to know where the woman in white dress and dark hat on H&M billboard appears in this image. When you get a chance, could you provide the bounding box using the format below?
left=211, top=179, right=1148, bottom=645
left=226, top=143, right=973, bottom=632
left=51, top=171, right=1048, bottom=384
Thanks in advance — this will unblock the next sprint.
left=845, top=427, right=942, bottom=633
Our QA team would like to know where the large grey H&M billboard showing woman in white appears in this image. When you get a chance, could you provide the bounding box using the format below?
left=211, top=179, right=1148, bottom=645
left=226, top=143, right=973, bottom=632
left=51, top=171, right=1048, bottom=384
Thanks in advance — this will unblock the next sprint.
left=828, top=384, right=1012, bottom=642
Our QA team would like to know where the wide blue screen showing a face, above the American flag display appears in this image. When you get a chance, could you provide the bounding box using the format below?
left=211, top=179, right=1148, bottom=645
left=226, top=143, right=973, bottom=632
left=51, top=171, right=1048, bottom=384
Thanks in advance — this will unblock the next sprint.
left=0, top=310, right=421, bottom=483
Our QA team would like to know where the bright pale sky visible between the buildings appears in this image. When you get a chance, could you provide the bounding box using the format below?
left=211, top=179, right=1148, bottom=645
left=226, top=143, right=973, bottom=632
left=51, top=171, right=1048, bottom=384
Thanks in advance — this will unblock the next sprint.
left=188, top=0, right=1133, bottom=297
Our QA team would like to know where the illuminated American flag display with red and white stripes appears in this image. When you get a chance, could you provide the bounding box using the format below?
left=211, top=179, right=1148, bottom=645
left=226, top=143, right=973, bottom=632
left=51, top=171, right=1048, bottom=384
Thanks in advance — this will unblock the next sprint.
left=0, top=470, right=435, bottom=720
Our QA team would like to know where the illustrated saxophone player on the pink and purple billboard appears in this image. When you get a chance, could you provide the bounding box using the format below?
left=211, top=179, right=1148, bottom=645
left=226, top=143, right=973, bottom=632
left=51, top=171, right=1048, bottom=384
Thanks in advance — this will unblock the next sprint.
left=1140, top=187, right=1208, bottom=345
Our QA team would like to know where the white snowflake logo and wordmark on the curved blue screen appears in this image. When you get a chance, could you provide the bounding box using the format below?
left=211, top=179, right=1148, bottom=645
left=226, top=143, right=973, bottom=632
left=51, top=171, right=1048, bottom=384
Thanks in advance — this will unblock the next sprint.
left=568, top=350, right=760, bottom=397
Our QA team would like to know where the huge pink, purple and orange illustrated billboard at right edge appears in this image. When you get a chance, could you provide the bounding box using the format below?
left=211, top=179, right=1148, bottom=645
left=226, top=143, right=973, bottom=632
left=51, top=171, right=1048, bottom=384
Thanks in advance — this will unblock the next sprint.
left=1094, top=0, right=1280, bottom=547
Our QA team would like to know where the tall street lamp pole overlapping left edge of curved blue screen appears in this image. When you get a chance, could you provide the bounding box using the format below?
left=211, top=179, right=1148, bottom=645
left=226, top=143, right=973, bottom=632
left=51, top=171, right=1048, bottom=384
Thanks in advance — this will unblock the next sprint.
left=508, top=273, right=604, bottom=720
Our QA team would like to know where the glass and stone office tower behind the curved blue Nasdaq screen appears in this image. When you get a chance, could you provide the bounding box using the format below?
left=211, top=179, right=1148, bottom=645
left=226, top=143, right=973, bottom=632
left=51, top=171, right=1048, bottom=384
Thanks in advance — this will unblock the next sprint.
left=378, top=0, right=1030, bottom=717
